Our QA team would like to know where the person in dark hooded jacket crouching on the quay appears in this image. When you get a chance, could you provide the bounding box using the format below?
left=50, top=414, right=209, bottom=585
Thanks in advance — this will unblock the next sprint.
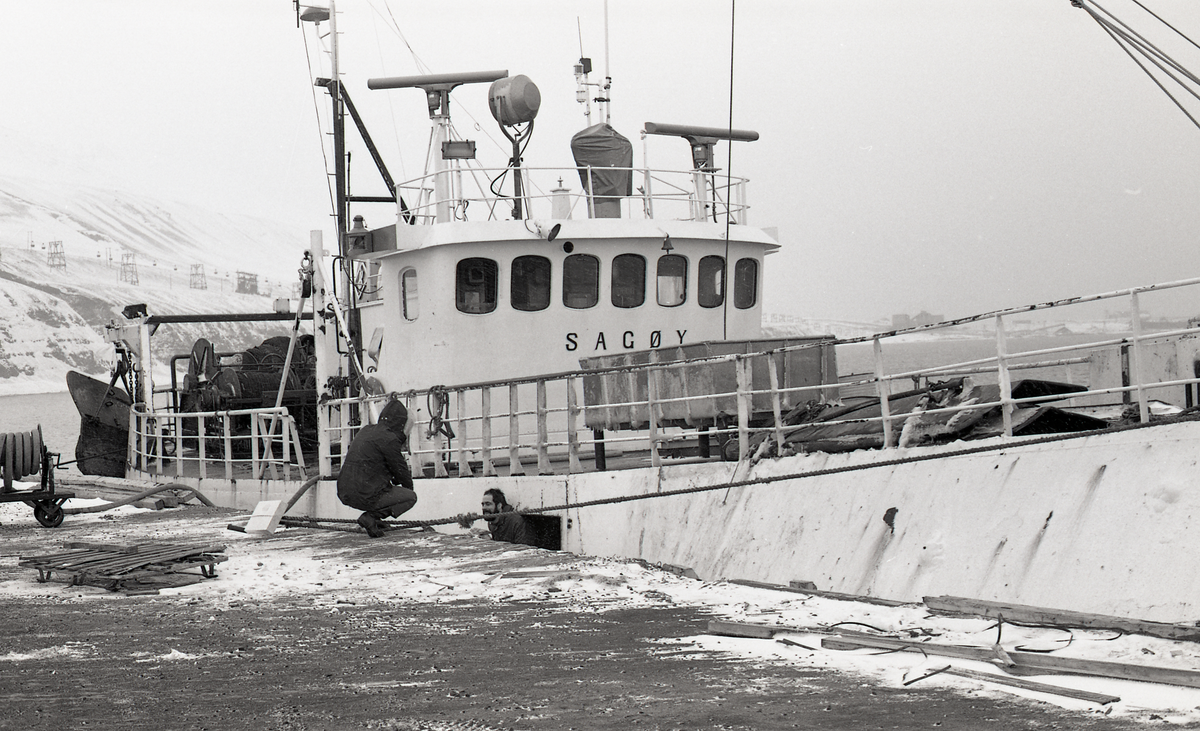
left=337, top=401, right=416, bottom=538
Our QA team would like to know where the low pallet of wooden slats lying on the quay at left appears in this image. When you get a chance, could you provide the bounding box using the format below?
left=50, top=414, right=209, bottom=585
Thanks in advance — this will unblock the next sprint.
left=17, top=543, right=226, bottom=594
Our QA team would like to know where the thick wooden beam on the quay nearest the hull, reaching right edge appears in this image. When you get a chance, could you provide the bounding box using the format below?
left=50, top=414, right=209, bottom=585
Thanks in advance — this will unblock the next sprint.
left=924, top=597, right=1200, bottom=642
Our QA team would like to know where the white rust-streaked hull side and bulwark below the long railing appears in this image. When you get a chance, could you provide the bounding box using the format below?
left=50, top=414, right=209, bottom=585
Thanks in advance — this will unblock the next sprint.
left=404, top=423, right=1200, bottom=622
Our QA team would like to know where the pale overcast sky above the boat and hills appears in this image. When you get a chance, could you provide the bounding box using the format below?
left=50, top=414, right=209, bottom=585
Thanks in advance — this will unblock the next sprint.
left=0, top=0, right=1200, bottom=320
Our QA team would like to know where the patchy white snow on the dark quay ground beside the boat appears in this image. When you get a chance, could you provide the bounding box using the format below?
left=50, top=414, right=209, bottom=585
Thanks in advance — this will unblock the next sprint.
left=0, top=501, right=1200, bottom=724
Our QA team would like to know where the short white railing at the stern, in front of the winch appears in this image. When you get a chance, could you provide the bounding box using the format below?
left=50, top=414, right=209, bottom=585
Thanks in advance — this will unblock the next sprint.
left=128, top=403, right=305, bottom=480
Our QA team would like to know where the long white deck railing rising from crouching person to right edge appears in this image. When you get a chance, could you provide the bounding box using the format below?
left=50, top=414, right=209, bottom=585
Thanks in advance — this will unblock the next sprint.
left=323, top=278, right=1200, bottom=477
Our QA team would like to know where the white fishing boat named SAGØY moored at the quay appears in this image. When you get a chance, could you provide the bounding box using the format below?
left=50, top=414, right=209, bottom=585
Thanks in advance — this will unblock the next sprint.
left=63, top=6, right=1200, bottom=622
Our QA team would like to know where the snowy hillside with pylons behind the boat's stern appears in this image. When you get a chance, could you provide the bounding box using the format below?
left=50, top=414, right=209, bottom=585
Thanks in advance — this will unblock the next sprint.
left=0, top=169, right=319, bottom=394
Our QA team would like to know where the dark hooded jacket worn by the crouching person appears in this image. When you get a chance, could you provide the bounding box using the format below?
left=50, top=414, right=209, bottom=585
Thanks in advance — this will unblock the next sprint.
left=337, top=401, right=413, bottom=510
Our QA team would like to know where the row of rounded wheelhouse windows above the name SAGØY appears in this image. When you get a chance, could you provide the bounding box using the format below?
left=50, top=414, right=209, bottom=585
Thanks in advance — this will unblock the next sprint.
left=424, top=253, right=758, bottom=319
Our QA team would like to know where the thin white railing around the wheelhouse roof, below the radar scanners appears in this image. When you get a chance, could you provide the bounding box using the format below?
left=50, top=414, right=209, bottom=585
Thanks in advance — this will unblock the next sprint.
left=397, top=167, right=750, bottom=224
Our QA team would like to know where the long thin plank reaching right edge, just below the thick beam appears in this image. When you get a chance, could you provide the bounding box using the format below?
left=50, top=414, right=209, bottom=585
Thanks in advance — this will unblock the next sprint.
left=821, top=631, right=1200, bottom=688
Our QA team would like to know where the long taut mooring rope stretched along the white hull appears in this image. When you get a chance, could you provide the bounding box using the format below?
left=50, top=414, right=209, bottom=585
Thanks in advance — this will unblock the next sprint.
left=280, top=414, right=1200, bottom=531
